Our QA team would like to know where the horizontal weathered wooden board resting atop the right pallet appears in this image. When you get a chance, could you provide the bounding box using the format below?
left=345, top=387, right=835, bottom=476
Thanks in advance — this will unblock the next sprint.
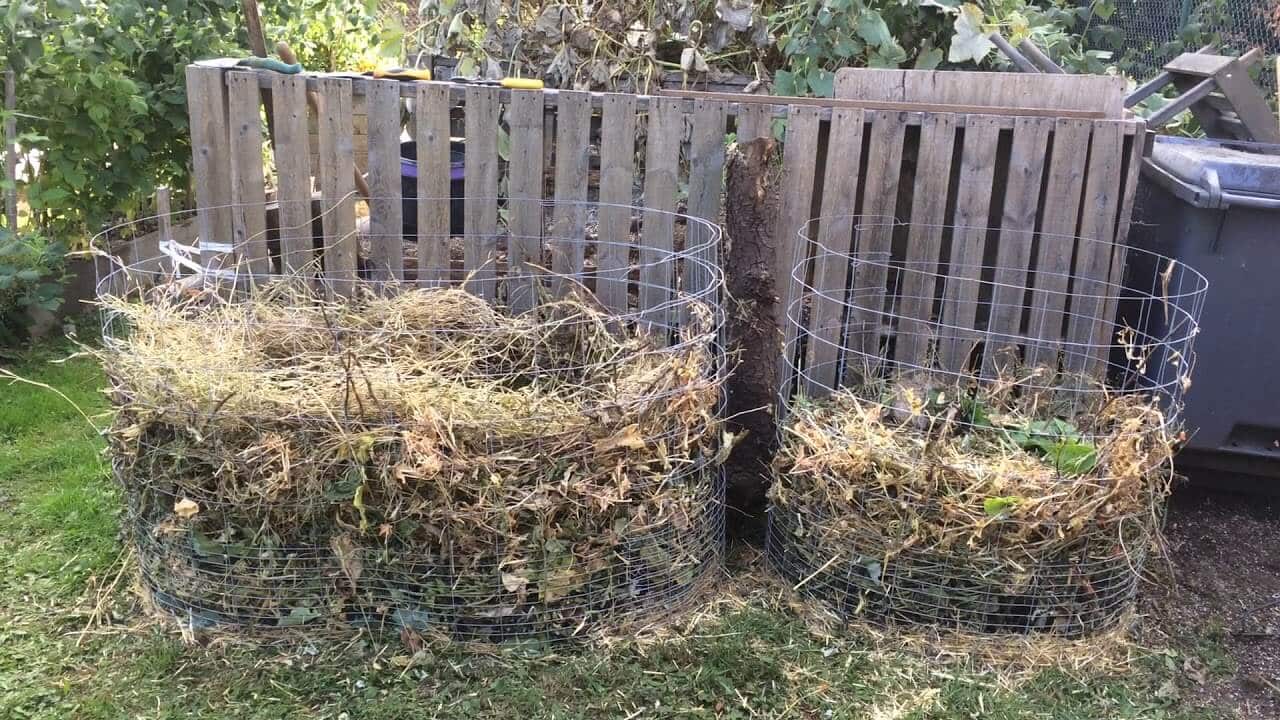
left=836, top=68, right=1125, bottom=119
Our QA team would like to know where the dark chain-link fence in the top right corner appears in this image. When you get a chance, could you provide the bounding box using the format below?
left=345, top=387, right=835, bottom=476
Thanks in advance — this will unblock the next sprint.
left=1106, top=0, right=1280, bottom=96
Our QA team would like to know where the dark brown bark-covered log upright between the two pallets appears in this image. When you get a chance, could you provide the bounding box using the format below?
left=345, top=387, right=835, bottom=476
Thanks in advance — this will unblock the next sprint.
left=721, top=138, right=782, bottom=536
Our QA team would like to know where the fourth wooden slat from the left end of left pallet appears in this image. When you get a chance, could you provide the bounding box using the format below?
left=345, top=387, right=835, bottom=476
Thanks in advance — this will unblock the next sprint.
left=319, top=77, right=360, bottom=296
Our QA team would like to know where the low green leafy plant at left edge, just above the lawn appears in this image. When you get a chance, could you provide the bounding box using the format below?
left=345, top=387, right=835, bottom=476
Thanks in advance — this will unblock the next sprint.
left=0, top=228, right=65, bottom=347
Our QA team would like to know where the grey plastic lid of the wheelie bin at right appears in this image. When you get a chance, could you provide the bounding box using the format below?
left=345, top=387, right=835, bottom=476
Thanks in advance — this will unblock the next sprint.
left=1151, top=136, right=1280, bottom=197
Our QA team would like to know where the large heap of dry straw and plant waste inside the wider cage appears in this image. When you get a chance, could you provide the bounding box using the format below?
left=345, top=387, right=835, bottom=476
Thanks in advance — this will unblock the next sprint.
left=104, top=282, right=719, bottom=639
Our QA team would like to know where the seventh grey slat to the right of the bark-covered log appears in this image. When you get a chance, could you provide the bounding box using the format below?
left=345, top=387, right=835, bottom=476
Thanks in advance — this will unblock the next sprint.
left=1027, top=119, right=1093, bottom=365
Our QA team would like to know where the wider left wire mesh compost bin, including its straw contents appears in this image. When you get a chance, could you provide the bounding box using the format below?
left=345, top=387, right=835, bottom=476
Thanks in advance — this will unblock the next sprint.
left=97, top=199, right=723, bottom=642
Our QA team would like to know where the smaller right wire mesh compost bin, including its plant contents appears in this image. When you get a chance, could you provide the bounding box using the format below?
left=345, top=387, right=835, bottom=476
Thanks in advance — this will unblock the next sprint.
left=768, top=218, right=1207, bottom=635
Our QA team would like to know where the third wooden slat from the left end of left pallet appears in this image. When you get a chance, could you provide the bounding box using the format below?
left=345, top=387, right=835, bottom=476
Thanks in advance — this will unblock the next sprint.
left=271, top=73, right=314, bottom=273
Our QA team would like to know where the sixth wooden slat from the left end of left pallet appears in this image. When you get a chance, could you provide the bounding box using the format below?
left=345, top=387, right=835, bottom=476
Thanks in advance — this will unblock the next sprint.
left=413, top=82, right=451, bottom=286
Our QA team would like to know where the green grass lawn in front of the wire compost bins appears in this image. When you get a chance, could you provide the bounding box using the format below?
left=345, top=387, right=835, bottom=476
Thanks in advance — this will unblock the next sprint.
left=0, top=350, right=1225, bottom=720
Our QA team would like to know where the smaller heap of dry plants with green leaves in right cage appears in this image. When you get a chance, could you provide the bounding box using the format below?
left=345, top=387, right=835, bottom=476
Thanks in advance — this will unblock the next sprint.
left=771, top=368, right=1174, bottom=635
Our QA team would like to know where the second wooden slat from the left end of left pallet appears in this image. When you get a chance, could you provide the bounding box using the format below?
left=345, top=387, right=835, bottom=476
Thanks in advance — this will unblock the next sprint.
left=227, top=72, right=271, bottom=274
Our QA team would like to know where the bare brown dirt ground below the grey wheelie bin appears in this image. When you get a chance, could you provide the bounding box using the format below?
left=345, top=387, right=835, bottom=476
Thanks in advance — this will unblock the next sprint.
left=1146, top=487, right=1280, bottom=720
